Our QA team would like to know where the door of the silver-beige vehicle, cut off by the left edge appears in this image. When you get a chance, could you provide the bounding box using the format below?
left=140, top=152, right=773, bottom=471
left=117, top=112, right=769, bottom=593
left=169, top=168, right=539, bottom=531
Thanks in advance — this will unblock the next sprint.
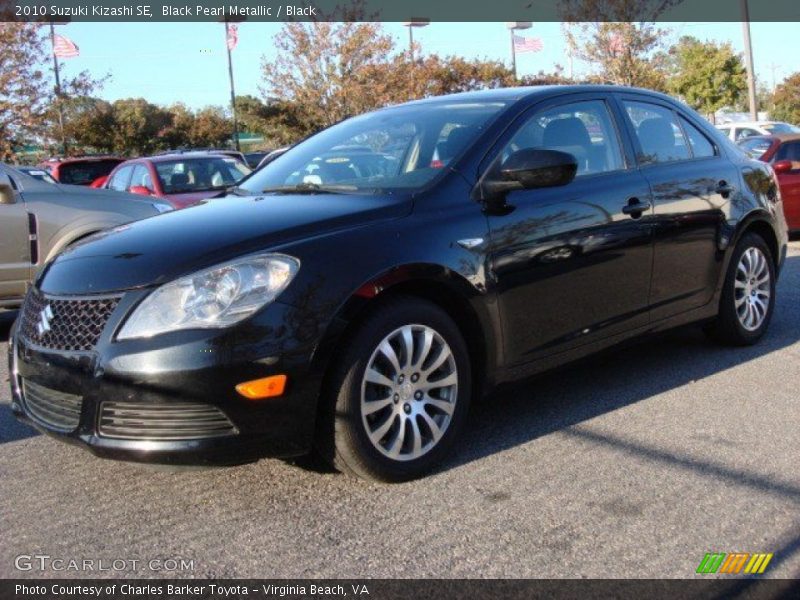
left=0, top=166, right=31, bottom=306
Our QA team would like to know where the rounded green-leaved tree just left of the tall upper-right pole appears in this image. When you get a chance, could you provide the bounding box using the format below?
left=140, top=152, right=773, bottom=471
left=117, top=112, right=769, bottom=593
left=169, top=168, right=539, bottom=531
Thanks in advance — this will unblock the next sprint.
left=667, top=36, right=747, bottom=115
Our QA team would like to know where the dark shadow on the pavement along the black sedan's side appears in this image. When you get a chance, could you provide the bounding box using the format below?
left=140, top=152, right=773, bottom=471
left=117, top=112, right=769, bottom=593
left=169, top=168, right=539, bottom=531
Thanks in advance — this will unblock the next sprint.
left=442, top=256, right=800, bottom=474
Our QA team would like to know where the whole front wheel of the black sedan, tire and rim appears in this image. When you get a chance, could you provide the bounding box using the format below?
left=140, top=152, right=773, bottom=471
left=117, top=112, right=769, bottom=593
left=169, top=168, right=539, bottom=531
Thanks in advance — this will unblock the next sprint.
left=319, top=297, right=472, bottom=482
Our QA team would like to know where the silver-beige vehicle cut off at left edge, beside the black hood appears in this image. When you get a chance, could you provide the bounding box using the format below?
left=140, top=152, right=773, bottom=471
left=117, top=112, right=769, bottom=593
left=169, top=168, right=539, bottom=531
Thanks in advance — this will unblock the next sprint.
left=0, top=163, right=172, bottom=309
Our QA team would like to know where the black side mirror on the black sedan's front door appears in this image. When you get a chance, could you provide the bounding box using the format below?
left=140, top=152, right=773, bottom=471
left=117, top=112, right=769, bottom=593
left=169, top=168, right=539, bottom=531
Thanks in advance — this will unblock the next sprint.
left=481, top=148, right=578, bottom=203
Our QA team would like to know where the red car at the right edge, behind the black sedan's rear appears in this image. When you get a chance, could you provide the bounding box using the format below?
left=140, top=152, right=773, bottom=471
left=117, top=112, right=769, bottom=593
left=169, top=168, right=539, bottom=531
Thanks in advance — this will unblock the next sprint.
left=739, top=133, right=800, bottom=233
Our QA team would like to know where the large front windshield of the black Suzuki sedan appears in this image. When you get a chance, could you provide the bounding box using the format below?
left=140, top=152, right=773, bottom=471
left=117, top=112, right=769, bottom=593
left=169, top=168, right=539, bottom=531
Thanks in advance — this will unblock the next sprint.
left=242, top=102, right=505, bottom=194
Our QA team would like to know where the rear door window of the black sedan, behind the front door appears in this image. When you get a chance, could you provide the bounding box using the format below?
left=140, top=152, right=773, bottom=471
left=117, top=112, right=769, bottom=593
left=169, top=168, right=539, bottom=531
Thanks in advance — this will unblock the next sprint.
left=624, top=101, right=691, bottom=165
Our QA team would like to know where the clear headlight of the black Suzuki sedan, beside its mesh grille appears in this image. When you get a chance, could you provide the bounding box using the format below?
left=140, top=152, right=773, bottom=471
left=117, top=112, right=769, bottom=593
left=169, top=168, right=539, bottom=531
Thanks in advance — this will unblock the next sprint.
left=117, top=254, right=300, bottom=340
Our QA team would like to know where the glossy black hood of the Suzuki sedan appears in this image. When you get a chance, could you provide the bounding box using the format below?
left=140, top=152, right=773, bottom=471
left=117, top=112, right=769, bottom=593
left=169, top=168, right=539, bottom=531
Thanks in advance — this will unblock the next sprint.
left=38, top=194, right=411, bottom=295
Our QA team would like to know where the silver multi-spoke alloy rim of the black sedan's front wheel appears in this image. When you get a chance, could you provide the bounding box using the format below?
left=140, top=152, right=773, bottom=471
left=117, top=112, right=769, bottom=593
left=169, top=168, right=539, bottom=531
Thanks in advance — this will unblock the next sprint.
left=360, top=324, right=458, bottom=461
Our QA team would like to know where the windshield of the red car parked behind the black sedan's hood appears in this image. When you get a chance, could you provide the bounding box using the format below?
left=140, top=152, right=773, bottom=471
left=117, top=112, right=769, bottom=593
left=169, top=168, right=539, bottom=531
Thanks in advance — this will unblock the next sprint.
left=155, top=156, right=250, bottom=194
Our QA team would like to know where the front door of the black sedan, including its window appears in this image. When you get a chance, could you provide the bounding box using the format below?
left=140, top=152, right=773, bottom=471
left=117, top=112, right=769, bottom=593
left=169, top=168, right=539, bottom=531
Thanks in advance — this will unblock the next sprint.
left=488, top=94, right=652, bottom=366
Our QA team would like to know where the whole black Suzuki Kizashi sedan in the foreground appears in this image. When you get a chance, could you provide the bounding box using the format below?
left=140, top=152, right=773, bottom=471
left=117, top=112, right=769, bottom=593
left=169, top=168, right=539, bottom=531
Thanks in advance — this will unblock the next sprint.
left=9, top=86, right=787, bottom=481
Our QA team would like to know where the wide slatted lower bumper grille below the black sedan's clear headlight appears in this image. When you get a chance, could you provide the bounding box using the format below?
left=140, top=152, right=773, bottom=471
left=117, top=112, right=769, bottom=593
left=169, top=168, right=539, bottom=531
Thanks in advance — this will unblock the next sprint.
left=98, top=402, right=236, bottom=441
